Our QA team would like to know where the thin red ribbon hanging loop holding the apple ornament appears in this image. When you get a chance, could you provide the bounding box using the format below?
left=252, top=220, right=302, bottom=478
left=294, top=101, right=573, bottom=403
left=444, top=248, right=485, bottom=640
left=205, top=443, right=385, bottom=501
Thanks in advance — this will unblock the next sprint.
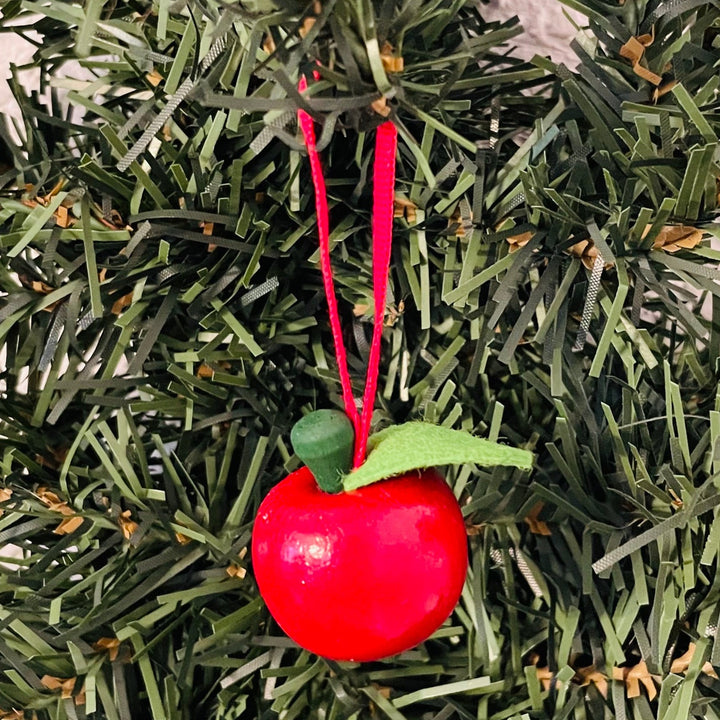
left=298, top=77, right=397, bottom=468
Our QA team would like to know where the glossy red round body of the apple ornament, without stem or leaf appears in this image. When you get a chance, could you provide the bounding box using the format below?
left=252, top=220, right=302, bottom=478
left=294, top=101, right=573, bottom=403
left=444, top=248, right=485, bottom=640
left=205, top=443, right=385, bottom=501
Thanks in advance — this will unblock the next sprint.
left=252, top=467, right=467, bottom=661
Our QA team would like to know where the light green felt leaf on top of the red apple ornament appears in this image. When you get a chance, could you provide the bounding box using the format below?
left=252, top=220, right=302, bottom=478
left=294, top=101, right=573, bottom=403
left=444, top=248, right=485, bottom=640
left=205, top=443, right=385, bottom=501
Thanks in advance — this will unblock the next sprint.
left=343, top=422, right=533, bottom=490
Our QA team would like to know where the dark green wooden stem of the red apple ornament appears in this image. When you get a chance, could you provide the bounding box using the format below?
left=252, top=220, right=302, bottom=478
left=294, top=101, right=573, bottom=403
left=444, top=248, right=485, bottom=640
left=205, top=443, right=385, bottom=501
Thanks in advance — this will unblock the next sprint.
left=290, top=410, right=355, bottom=493
